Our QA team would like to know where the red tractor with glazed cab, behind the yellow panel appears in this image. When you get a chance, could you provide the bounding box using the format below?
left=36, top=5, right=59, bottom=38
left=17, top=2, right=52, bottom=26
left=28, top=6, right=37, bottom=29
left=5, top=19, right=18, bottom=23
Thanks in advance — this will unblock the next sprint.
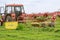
left=2, top=4, right=25, bottom=22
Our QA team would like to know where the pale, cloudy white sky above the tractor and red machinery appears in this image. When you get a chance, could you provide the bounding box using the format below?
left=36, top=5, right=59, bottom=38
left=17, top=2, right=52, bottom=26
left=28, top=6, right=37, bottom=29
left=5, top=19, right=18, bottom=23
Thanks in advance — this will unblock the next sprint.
left=0, top=0, right=60, bottom=13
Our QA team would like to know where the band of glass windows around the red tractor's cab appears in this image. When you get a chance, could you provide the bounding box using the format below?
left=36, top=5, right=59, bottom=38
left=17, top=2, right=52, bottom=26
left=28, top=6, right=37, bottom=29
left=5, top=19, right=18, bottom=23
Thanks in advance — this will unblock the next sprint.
left=6, top=6, right=24, bottom=15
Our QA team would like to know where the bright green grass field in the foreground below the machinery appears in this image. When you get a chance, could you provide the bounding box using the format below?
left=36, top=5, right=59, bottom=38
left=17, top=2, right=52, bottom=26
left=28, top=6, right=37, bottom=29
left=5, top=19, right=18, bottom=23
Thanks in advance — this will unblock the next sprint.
left=0, top=18, right=60, bottom=40
